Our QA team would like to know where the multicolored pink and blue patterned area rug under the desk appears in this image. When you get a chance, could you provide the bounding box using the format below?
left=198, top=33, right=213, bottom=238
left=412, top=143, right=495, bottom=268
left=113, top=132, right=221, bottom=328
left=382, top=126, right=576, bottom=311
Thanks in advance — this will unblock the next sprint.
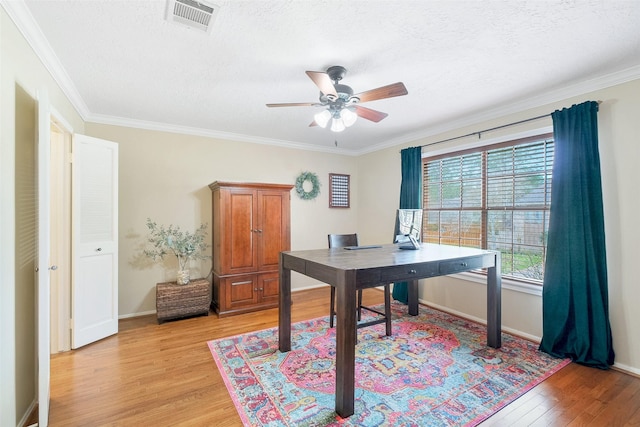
left=208, top=302, right=570, bottom=426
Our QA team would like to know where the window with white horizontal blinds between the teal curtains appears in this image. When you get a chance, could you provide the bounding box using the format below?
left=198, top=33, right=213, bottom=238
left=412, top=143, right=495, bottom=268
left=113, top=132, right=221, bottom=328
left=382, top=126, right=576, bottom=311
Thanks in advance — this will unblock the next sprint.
left=423, top=134, right=554, bottom=284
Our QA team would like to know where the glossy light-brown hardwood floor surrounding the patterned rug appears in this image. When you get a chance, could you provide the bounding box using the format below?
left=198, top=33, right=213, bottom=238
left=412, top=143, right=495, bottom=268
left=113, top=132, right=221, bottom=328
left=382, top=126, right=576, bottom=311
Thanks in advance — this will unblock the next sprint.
left=49, top=287, right=640, bottom=426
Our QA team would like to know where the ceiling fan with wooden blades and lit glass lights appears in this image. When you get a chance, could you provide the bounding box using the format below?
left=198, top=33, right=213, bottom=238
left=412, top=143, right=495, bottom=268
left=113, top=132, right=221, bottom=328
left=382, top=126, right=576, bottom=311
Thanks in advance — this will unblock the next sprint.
left=267, top=65, right=408, bottom=132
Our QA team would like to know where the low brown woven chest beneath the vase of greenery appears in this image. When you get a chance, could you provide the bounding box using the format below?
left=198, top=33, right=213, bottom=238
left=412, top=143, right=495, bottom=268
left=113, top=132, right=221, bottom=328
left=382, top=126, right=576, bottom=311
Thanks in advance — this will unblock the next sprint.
left=156, top=279, right=211, bottom=323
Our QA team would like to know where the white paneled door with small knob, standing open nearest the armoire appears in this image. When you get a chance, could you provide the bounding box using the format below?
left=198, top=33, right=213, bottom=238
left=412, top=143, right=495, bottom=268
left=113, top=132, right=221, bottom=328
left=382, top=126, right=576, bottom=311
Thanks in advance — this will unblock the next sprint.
left=71, top=134, right=118, bottom=348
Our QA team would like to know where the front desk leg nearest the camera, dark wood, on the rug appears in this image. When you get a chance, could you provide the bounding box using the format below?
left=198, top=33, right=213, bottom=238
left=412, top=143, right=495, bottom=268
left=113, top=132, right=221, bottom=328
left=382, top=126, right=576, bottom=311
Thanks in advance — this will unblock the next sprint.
left=336, top=270, right=356, bottom=418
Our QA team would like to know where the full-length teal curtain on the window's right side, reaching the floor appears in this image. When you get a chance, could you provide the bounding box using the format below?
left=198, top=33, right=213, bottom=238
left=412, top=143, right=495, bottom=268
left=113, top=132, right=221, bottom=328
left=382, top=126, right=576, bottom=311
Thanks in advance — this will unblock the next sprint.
left=540, top=101, right=615, bottom=369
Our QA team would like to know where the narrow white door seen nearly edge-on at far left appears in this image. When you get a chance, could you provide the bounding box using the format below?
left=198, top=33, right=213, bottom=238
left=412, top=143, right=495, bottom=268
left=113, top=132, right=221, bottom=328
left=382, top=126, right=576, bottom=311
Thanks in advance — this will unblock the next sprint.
left=36, top=91, right=55, bottom=427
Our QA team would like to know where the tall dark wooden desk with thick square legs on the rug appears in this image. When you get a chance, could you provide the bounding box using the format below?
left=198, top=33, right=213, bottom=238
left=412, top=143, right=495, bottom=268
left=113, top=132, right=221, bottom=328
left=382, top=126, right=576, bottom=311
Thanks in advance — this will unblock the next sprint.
left=278, top=243, right=502, bottom=417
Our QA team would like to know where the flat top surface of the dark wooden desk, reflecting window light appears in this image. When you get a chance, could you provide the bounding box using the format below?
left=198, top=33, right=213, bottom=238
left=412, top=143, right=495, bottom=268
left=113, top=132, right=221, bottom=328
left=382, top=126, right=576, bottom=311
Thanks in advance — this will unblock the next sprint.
left=283, top=243, right=495, bottom=270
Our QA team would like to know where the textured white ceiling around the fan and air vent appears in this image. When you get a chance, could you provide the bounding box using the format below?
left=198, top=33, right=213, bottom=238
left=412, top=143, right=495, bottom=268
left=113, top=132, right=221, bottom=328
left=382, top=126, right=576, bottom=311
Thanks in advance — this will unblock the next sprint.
left=8, top=0, right=640, bottom=152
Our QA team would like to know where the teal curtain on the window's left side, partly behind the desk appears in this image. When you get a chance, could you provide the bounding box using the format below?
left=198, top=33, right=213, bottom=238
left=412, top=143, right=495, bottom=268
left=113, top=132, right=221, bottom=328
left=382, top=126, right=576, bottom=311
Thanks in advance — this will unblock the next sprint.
left=393, top=147, right=422, bottom=304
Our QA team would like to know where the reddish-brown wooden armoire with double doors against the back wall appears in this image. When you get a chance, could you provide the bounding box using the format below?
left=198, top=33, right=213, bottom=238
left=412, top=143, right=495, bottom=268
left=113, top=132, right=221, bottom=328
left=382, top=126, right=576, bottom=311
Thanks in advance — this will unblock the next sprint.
left=209, top=181, right=293, bottom=317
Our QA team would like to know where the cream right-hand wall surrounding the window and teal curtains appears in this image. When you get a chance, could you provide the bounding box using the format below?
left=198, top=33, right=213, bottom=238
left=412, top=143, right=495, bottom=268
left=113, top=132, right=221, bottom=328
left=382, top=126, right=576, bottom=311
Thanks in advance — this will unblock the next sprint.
left=358, top=80, right=640, bottom=374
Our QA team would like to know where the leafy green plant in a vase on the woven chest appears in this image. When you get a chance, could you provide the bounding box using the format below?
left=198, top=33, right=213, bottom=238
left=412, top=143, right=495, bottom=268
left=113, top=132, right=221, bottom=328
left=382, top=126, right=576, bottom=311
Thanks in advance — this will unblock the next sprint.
left=144, top=218, right=209, bottom=285
